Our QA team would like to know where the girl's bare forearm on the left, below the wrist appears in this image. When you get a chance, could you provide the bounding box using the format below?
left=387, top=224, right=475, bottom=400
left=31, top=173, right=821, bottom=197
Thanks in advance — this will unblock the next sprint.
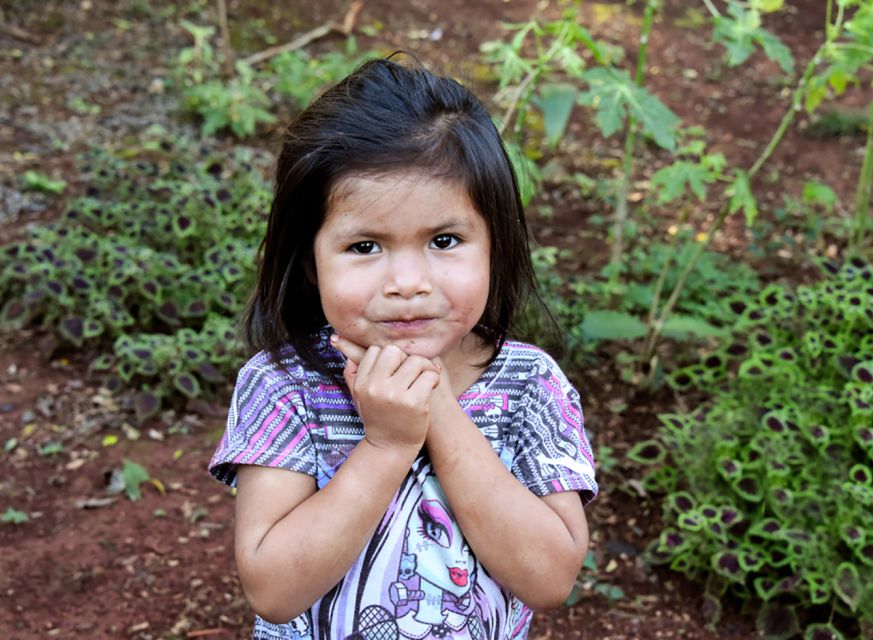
left=237, top=439, right=416, bottom=623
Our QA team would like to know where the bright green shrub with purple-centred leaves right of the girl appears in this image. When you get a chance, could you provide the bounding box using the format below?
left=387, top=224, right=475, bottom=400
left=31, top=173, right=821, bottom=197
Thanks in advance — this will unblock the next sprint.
left=631, top=259, right=873, bottom=637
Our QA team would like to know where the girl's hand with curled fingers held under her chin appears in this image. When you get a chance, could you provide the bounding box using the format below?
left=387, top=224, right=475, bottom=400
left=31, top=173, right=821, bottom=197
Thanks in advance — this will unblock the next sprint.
left=331, top=336, right=440, bottom=453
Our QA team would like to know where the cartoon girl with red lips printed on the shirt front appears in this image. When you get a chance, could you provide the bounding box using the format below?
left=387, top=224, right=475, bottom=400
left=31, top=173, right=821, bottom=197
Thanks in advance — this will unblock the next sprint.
left=389, top=476, right=482, bottom=640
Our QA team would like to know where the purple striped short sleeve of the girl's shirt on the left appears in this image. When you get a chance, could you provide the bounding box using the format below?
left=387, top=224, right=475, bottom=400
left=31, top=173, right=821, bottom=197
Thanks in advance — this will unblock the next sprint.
left=209, top=356, right=317, bottom=485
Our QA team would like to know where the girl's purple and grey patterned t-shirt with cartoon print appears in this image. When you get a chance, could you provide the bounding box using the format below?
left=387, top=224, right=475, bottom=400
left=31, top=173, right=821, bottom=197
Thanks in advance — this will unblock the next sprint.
left=210, top=333, right=597, bottom=640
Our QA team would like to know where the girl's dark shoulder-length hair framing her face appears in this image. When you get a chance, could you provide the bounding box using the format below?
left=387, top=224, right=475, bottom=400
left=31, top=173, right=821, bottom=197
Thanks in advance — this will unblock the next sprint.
left=243, top=59, right=536, bottom=371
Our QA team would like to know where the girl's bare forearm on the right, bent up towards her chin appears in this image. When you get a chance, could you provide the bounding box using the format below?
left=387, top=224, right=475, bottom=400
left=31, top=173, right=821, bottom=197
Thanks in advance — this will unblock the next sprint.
left=427, top=403, right=588, bottom=609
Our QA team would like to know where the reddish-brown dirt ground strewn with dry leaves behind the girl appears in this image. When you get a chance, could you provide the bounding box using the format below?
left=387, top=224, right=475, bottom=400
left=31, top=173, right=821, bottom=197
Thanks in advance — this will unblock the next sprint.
left=0, top=0, right=864, bottom=640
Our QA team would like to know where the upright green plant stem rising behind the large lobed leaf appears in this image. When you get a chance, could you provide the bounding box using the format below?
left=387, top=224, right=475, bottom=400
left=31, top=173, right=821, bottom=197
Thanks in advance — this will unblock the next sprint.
left=609, top=0, right=660, bottom=285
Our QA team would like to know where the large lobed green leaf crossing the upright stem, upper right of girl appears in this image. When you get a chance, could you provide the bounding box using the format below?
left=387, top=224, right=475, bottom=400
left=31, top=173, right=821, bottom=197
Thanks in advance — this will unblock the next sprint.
left=579, top=67, right=680, bottom=151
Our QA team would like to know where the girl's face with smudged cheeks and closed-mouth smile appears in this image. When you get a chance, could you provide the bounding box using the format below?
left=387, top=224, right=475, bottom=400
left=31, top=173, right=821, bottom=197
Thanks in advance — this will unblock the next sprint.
left=315, top=172, right=491, bottom=373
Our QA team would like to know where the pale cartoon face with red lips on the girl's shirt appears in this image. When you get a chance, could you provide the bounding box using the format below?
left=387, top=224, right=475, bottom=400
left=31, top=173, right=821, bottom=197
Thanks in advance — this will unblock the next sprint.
left=406, top=476, right=475, bottom=597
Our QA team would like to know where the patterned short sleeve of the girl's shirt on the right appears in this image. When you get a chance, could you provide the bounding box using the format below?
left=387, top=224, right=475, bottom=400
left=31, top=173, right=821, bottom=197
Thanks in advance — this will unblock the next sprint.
left=512, top=354, right=598, bottom=504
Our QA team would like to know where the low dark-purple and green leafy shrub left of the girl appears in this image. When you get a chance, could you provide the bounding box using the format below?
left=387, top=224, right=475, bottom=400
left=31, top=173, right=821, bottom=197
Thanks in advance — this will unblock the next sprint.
left=0, top=132, right=270, bottom=417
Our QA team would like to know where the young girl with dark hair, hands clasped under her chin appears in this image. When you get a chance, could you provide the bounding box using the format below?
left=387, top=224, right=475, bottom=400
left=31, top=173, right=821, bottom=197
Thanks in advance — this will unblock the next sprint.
left=210, top=60, right=597, bottom=640
